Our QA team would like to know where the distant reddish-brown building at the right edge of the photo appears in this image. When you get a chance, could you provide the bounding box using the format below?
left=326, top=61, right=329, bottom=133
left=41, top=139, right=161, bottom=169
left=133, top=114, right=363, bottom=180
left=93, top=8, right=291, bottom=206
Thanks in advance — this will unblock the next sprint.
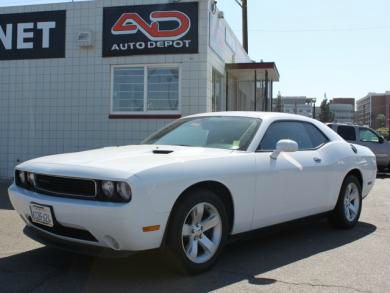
left=356, top=91, right=390, bottom=129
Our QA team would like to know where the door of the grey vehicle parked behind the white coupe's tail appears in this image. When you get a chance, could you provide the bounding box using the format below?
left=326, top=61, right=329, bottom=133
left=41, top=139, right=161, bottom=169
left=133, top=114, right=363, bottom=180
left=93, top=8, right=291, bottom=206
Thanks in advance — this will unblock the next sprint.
left=359, top=127, right=389, bottom=168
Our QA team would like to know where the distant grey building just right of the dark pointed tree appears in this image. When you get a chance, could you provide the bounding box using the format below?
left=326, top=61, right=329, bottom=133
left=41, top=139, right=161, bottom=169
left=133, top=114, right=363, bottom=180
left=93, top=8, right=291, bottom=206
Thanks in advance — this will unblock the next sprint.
left=329, top=98, right=355, bottom=123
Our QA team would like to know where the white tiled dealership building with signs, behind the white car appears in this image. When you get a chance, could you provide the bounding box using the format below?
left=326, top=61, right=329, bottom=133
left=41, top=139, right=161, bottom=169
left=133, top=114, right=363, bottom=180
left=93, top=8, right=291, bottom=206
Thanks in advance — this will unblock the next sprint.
left=0, top=0, right=279, bottom=178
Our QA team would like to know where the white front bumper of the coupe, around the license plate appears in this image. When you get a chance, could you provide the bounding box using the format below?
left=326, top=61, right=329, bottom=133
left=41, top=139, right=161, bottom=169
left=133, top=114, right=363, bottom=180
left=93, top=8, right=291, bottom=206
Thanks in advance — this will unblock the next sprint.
left=8, top=184, right=168, bottom=251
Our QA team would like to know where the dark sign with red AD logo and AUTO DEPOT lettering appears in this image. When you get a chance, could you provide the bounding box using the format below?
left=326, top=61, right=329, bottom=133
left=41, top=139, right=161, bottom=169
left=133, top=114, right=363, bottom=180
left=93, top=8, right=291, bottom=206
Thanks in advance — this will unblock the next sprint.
left=103, top=2, right=198, bottom=57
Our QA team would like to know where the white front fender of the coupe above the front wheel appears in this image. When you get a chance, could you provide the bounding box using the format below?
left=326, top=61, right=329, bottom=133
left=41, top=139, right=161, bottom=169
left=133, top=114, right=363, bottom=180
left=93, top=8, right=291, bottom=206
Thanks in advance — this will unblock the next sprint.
left=135, top=153, right=255, bottom=233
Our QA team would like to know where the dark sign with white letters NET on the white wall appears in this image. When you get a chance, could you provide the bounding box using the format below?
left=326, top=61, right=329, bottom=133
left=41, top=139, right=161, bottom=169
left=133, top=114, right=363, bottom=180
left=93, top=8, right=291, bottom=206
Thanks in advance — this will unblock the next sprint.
left=0, top=10, right=66, bottom=60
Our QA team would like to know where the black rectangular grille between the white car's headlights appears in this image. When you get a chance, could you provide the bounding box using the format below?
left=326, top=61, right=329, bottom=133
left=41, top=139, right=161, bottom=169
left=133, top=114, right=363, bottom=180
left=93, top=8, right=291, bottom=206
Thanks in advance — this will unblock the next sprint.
left=35, top=174, right=97, bottom=197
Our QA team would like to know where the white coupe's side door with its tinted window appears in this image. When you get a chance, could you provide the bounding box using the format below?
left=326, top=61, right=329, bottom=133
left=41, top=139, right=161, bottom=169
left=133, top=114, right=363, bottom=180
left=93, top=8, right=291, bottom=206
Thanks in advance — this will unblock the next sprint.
left=253, top=120, right=330, bottom=228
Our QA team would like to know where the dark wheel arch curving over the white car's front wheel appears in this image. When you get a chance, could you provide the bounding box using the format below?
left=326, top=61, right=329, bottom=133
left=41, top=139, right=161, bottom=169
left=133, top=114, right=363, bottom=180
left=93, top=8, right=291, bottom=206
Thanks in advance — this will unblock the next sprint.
left=162, top=180, right=234, bottom=246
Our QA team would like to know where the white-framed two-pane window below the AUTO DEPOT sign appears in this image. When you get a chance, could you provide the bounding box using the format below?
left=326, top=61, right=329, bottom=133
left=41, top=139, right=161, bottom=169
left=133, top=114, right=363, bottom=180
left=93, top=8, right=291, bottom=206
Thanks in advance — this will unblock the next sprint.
left=111, top=66, right=179, bottom=114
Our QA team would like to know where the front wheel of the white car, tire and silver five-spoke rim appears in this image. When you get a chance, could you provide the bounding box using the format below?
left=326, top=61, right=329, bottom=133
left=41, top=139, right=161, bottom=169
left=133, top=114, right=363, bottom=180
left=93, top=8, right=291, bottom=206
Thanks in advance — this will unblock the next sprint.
left=166, top=189, right=228, bottom=274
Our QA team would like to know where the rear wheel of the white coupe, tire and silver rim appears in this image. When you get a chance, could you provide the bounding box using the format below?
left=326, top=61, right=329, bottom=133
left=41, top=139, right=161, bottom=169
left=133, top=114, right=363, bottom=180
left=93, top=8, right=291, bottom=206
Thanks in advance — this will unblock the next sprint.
left=330, top=175, right=362, bottom=229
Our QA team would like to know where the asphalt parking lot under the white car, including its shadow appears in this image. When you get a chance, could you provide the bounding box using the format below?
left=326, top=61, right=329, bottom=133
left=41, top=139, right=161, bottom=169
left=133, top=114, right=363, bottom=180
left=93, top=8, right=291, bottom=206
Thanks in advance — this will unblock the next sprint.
left=0, top=175, right=390, bottom=292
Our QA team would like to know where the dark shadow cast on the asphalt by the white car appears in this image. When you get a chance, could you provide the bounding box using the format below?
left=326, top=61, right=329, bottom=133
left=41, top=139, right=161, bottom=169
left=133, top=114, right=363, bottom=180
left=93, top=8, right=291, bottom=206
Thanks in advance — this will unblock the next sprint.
left=0, top=219, right=376, bottom=292
